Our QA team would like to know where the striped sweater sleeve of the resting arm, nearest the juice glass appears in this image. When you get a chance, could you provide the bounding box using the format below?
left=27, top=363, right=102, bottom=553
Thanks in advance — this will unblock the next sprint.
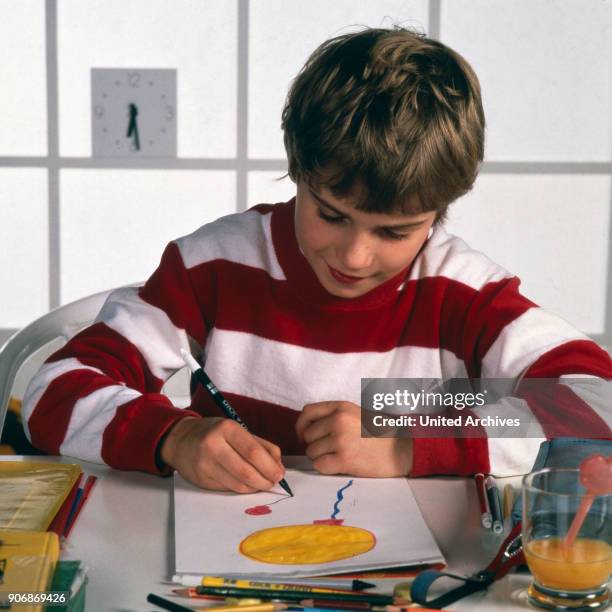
left=411, top=277, right=612, bottom=476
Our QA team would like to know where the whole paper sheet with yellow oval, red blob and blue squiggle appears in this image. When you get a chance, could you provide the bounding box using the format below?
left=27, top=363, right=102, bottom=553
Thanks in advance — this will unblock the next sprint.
left=173, top=466, right=441, bottom=584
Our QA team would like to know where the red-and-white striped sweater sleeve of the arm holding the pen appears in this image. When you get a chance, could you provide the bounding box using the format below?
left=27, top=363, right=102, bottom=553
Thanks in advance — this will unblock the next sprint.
left=23, top=243, right=208, bottom=473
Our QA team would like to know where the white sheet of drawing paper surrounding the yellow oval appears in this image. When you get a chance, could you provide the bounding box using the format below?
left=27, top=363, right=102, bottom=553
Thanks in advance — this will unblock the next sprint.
left=174, top=470, right=444, bottom=584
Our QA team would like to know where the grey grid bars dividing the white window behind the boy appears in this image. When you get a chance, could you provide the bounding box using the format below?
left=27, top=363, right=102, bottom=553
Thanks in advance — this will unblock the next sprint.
left=0, top=0, right=612, bottom=347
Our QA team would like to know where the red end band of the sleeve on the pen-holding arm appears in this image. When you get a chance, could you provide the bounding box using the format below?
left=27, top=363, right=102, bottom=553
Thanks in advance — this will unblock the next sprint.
left=102, top=393, right=201, bottom=476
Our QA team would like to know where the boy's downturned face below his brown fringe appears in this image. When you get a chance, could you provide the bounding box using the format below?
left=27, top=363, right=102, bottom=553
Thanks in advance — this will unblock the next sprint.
left=295, top=180, right=436, bottom=298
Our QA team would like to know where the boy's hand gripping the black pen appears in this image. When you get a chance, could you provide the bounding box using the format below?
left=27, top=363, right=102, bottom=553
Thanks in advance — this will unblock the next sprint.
left=160, top=417, right=285, bottom=493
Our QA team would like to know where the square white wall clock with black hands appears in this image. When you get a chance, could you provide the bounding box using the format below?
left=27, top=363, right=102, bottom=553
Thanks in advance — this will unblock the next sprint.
left=91, top=68, right=176, bottom=157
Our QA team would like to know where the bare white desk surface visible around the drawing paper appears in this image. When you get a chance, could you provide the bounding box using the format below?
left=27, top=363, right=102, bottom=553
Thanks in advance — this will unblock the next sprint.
left=2, top=457, right=530, bottom=612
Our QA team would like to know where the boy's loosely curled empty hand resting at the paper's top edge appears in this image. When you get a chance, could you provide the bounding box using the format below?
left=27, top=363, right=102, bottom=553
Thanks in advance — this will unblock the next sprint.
left=296, top=402, right=412, bottom=477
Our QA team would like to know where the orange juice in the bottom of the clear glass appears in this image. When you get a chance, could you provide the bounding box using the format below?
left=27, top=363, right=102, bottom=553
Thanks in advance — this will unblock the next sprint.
left=524, top=537, right=612, bottom=591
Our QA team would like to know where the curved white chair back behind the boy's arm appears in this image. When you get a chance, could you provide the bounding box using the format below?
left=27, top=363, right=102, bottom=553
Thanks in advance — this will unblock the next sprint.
left=0, top=289, right=113, bottom=432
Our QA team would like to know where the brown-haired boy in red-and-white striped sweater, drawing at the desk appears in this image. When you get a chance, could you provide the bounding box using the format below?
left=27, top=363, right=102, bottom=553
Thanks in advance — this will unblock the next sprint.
left=24, top=28, right=612, bottom=493
